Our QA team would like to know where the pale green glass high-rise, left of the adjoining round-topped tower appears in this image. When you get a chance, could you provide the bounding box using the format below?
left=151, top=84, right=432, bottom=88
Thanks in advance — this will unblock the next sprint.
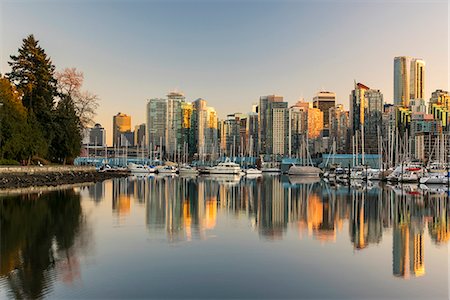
left=147, top=98, right=167, bottom=157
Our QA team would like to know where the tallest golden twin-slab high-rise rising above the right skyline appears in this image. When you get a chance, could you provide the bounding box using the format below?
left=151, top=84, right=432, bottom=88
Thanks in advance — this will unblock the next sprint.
left=394, top=56, right=425, bottom=107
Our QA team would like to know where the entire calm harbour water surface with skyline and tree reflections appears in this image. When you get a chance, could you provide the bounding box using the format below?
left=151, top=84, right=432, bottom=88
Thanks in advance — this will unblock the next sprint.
left=0, top=176, right=450, bottom=299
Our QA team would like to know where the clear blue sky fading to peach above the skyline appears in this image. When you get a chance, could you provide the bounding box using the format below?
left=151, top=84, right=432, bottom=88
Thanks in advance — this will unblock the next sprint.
left=0, top=0, right=449, bottom=143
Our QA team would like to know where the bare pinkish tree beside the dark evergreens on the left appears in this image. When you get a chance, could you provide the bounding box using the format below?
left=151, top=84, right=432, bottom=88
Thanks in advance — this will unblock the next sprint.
left=56, top=68, right=99, bottom=128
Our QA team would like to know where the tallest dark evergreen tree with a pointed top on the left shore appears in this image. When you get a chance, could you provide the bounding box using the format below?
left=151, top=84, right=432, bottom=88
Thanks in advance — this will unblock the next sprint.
left=6, top=35, right=56, bottom=151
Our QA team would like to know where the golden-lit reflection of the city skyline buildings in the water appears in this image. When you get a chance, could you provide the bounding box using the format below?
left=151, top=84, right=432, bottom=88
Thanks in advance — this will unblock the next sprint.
left=146, top=176, right=450, bottom=279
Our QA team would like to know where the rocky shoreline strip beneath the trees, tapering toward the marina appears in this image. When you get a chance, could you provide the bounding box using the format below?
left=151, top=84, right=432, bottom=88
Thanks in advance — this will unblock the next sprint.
left=0, top=166, right=128, bottom=190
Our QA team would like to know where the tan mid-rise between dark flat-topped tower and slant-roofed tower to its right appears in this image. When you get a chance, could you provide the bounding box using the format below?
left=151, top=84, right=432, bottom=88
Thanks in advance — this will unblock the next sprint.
left=329, top=104, right=349, bottom=153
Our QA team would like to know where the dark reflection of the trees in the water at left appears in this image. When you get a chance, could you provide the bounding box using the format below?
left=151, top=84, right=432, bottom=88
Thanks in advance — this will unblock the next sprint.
left=0, top=189, right=89, bottom=299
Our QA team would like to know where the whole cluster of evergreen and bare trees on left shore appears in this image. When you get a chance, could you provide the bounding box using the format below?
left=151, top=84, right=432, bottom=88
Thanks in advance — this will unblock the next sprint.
left=0, top=35, right=98, bottom=163
